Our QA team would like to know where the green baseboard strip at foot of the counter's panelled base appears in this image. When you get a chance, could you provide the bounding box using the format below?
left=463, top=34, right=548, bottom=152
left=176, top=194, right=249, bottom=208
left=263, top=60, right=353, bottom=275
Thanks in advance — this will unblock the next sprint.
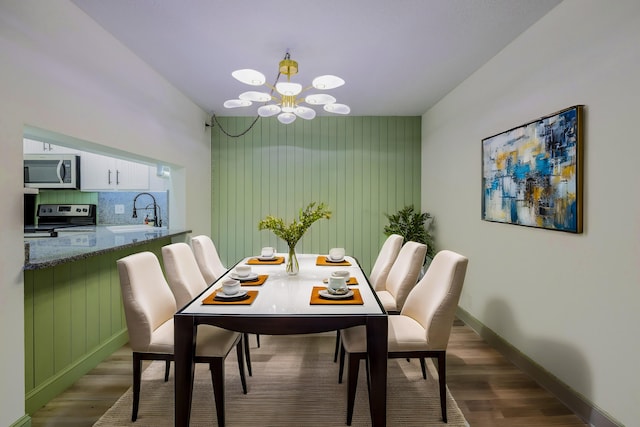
left=24, top=329, right=129, bottom=416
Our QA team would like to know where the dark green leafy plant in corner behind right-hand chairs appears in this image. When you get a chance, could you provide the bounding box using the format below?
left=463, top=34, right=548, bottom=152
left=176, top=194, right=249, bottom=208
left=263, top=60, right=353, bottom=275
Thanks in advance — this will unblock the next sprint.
left=384, top=205, right=436, bottom=258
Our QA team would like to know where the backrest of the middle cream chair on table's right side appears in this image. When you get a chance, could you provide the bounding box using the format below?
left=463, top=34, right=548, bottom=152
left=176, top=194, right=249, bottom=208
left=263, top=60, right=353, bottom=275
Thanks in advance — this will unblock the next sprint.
left=385, top=242, right=427, bottom=310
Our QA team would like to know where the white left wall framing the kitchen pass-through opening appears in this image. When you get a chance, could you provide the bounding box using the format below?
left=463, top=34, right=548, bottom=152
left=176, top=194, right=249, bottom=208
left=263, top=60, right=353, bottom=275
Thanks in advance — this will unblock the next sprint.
left=0, top=0, right=211, bottom=426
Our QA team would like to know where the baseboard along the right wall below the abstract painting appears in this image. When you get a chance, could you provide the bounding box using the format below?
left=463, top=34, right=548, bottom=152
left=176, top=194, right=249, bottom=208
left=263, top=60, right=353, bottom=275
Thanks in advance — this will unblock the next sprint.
left=456, top=307, right=623, bottom=427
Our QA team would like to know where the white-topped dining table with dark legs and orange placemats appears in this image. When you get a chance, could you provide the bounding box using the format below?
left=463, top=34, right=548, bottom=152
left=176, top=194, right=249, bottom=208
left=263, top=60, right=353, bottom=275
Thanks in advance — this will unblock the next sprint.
left=174, top=254, right=388, bottom=427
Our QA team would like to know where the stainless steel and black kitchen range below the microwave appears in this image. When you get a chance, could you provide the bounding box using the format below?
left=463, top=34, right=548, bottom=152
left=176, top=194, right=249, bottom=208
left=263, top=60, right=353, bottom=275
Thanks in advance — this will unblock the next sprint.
left=24, top=204, right=96, bottom=238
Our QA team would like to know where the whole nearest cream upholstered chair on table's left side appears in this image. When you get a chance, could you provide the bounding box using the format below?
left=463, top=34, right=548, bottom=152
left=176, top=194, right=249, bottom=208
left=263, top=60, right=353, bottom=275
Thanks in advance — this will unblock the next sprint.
left=116, top=252, right=247, bottom=425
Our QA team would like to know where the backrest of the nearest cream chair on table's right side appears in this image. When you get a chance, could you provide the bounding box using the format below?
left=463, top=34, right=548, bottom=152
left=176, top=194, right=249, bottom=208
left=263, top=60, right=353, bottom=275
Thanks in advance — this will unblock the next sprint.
left=400, top=250, right=469, bottom=350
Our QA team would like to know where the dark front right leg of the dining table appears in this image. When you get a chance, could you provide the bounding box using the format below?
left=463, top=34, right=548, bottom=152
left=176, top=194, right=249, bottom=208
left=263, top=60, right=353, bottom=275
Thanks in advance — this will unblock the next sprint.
left=367, top=316, right=389, bottom=427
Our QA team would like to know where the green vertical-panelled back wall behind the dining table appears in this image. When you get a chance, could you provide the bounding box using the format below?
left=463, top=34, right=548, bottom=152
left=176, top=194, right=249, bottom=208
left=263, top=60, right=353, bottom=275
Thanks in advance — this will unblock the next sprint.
left=211, top=116, right=421, bottom=273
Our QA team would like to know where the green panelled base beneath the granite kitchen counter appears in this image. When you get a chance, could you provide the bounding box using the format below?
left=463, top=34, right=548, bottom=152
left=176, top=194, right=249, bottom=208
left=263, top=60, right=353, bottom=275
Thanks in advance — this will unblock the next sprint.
left=24, top=237, right=171, bottom=414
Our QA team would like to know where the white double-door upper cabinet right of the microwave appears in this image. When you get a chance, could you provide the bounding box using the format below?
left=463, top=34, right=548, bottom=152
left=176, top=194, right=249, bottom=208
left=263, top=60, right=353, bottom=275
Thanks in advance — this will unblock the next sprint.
left=80, top=152, right=149, bottom=191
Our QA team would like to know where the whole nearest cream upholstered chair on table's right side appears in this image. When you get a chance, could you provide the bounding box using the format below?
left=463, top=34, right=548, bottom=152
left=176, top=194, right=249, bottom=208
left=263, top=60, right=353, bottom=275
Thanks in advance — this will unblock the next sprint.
left=340, top=250, right=469, bottom=425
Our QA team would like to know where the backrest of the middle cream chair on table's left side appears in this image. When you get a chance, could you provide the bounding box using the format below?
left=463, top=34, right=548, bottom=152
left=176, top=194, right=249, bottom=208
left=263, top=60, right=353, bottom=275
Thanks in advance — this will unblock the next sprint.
left=162, top=242, right=208, bottom=308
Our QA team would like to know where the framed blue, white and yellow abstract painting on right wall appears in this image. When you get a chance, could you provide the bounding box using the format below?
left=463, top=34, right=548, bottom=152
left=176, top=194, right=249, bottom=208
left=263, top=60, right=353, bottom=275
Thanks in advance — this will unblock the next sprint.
left=482, top=105, right=583, bottom=233
